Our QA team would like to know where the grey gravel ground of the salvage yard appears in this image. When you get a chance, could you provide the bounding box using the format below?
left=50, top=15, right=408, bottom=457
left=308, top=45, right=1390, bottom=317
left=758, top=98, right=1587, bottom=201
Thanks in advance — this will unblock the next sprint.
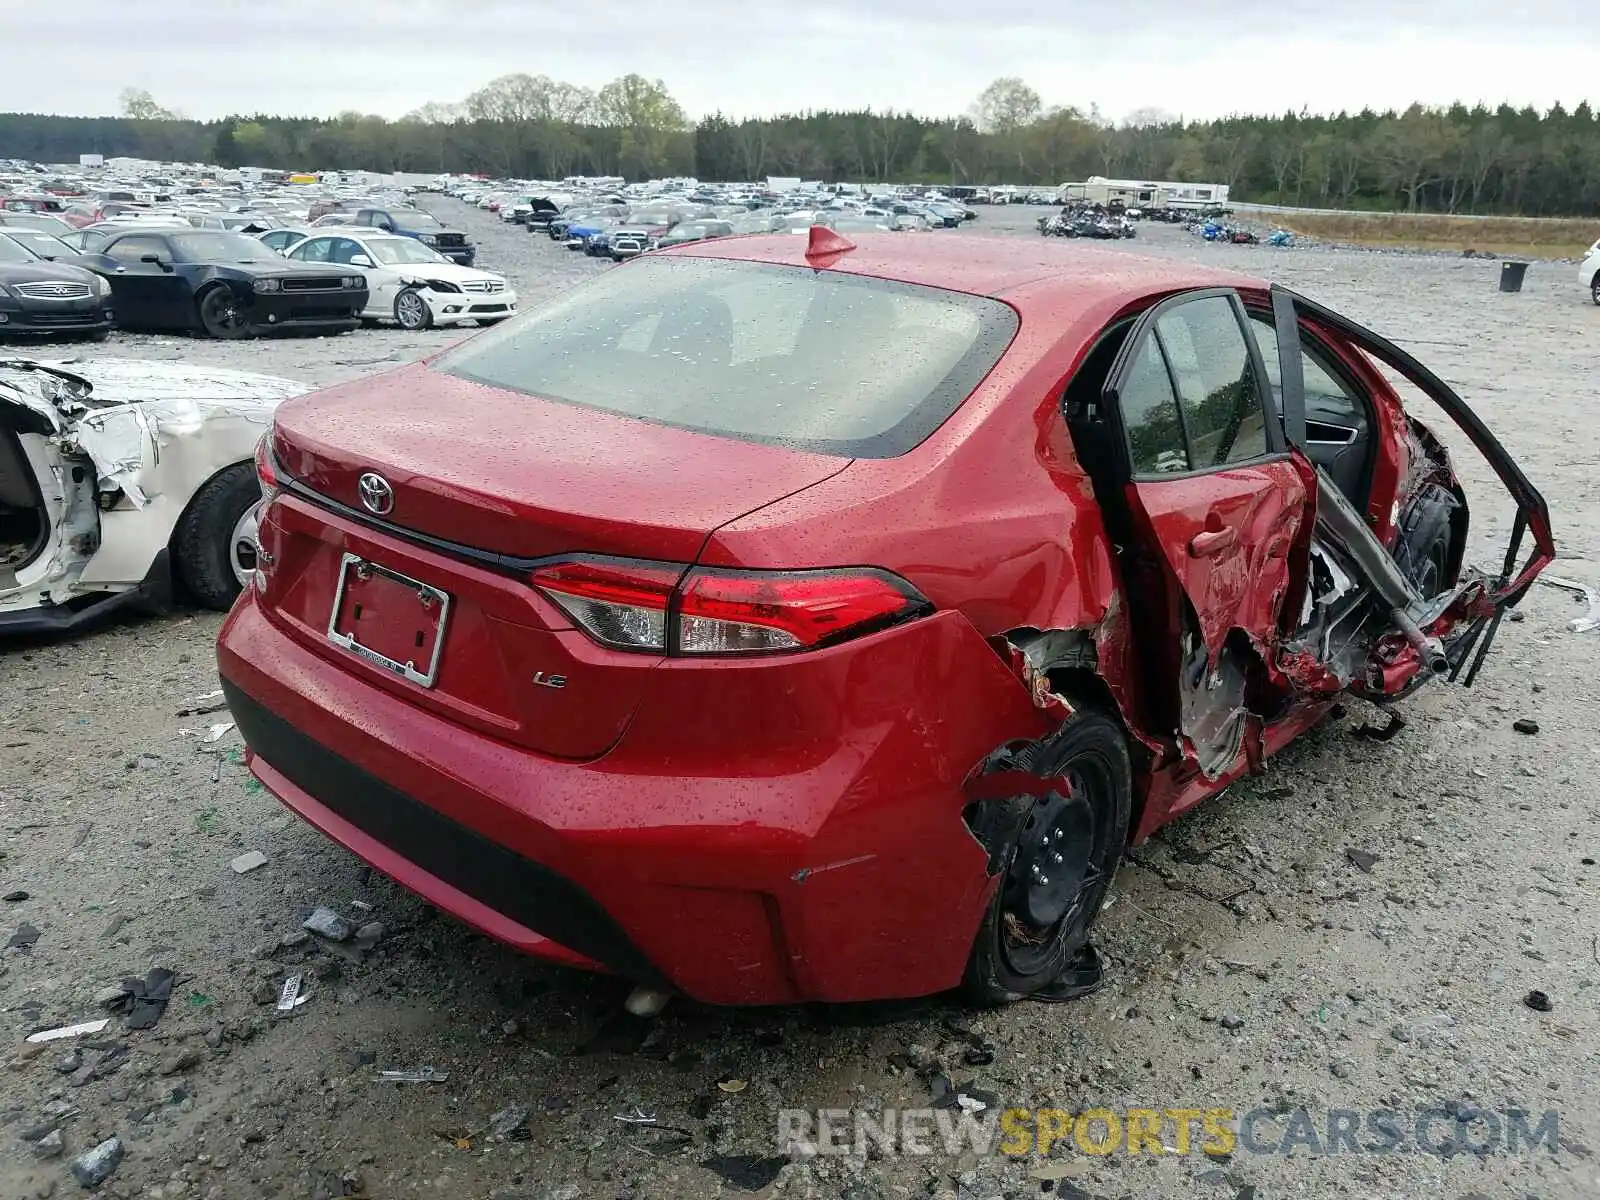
left=0, top=200, right=1600, bottom=1200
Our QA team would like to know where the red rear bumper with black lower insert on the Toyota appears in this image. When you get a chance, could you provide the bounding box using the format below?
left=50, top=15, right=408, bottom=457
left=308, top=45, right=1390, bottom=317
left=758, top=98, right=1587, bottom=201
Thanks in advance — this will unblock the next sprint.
left=218, top=592, right=1037, bottom=1005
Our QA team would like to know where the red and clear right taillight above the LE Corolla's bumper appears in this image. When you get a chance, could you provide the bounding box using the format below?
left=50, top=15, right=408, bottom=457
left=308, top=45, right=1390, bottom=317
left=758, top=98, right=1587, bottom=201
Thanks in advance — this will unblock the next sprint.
left=531, top=558, right=931, bottom=654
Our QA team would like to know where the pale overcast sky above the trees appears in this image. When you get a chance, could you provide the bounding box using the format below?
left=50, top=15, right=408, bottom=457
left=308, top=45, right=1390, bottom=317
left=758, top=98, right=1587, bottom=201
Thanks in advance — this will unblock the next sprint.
left=0, top=0, right=1600, bottom=118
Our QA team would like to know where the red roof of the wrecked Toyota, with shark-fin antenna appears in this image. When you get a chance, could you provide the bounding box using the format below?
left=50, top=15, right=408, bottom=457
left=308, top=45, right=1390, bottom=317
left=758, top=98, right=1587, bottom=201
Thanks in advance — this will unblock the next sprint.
left=662, top=230, right=1267, bottom=310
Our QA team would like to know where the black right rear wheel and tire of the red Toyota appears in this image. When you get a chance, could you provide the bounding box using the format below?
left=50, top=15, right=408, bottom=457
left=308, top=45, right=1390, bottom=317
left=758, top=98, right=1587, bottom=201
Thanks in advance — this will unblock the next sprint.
left=962, top=710, right=1133, bottom=1005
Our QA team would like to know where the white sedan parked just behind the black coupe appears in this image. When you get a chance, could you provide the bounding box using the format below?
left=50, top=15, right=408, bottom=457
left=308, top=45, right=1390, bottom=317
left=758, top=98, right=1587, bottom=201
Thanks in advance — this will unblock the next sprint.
left=283, top=229, right=517, bottom=330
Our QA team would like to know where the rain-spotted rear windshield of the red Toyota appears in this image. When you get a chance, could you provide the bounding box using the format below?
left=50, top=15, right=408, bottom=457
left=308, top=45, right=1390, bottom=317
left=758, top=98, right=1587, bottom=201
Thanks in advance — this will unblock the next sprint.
left=435, top=258, right=1016, bottom=458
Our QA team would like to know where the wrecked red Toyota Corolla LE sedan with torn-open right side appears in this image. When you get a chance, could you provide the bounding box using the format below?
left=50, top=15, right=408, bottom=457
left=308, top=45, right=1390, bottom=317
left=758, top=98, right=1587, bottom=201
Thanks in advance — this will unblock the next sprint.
left=219, top=230, right=1552, bottom=1003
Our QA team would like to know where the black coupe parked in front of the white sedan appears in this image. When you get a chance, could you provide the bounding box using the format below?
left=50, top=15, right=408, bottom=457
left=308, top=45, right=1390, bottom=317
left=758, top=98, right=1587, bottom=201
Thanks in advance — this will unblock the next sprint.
left=78, top=229, right=366, bottom=338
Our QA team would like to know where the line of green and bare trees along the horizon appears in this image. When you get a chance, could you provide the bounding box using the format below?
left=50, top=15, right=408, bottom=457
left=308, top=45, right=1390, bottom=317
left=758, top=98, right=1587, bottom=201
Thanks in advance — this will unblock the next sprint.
left=0, top=75, right=1600, bottom=216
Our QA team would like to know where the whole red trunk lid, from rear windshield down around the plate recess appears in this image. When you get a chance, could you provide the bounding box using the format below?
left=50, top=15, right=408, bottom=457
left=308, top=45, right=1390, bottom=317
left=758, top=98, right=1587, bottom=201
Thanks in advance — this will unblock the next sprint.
left=261, top=366, right=850, bottom=758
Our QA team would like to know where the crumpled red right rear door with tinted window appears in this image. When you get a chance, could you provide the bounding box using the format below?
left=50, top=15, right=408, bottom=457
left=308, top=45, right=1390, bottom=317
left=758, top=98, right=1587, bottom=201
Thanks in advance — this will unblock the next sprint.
left=1106, top=288, right=1314, bottom=666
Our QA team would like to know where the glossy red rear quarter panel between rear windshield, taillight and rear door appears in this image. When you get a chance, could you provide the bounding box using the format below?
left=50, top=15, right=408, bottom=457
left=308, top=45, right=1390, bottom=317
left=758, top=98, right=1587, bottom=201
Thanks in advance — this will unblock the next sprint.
left=701, top=291, right=1117, bottom=637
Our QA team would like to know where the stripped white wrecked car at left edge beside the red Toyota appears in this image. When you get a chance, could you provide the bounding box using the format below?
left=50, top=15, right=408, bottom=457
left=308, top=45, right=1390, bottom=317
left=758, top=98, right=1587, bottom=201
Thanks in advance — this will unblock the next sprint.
left=0, top=357, right=310, bottom=634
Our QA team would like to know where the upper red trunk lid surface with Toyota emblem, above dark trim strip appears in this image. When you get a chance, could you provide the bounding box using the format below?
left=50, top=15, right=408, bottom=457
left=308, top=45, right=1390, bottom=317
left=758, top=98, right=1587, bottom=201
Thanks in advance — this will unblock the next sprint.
left=272, top=365, right=850, bottom=563
